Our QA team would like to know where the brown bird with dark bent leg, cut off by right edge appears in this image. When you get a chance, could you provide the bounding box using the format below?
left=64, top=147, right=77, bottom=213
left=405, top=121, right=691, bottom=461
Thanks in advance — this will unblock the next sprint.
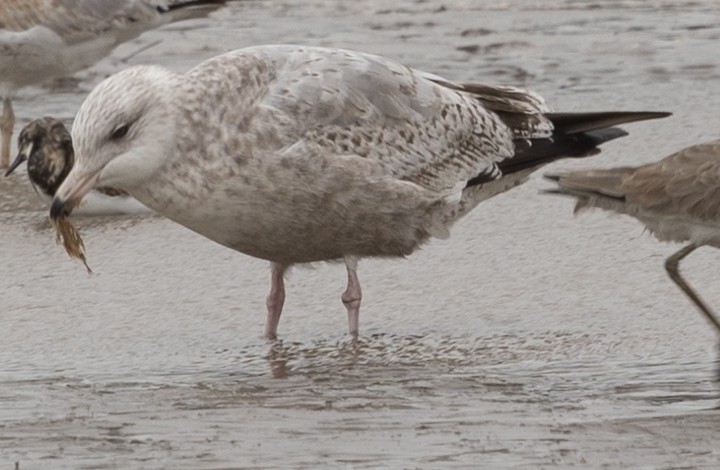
left=545, top=140, right=720, bottom=331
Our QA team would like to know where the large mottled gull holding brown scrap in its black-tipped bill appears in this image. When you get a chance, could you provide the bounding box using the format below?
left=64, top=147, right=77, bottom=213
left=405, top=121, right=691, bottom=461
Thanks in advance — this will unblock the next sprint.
left=51, top=46, right=666, bottom=338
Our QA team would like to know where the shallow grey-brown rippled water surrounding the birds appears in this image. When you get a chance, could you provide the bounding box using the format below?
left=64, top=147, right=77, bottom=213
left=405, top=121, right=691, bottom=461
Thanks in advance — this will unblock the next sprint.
left=0, top=0, right=720, bottom=469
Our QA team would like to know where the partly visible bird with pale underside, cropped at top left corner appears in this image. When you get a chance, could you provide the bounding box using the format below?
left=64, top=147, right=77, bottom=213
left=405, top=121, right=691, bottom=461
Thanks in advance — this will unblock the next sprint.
left=0, top=0, right=242, bottom=168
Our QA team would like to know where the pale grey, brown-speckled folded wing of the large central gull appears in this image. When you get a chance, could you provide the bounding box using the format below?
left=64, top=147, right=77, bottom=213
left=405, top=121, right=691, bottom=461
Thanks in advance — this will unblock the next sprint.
left=217, top=46, right=552, bottom=195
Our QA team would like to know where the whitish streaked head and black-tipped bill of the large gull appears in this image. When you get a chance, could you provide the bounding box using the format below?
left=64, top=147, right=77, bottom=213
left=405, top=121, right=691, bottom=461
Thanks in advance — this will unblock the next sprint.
left=50, top=66, right=177, bottom=219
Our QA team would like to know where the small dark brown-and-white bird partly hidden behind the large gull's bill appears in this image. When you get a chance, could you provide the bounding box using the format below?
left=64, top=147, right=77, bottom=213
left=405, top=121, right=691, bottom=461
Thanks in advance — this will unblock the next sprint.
left=5, top=117, right=152, bottom=215
